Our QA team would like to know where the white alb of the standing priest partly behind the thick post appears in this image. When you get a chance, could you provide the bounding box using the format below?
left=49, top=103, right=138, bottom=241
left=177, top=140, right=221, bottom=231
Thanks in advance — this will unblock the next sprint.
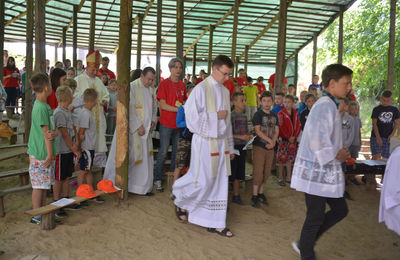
left=104, top=78, right=157, bottom=195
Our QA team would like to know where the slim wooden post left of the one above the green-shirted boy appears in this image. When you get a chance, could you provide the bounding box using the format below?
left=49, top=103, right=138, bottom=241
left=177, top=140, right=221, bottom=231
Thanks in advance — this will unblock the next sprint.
left=24, top=0, right=33, bottom=144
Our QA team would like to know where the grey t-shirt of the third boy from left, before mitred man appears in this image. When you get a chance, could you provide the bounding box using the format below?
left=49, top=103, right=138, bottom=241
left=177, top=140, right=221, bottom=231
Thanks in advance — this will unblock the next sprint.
left=79, top=107, right=96, bottom=150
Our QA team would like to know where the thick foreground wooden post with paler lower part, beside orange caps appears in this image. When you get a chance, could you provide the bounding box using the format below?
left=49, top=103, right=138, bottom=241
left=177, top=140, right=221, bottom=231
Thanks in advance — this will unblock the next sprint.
left=115, top=0, right=132, bottom=200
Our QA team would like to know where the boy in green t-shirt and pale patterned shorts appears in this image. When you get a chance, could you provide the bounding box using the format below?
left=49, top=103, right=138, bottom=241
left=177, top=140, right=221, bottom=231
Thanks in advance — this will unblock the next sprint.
left=27, top=73, right=57, bottom=224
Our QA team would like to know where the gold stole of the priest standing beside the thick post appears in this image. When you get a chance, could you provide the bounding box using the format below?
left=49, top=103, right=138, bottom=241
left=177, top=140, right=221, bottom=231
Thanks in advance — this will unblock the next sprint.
left=132, top=78, right=154, bottom=165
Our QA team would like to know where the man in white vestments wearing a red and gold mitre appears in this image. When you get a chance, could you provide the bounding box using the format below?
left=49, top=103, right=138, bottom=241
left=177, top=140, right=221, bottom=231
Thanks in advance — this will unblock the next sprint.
left=75, top=50, right=110, bottom=168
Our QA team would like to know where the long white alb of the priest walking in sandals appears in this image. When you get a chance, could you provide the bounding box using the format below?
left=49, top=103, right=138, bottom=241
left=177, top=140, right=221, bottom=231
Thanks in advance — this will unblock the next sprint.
left=172, top=76, right=233, bottom=228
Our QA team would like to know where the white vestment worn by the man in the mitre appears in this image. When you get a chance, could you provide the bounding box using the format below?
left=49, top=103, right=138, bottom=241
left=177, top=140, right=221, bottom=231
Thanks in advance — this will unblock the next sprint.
left=75, top=72, right=110, bottom=154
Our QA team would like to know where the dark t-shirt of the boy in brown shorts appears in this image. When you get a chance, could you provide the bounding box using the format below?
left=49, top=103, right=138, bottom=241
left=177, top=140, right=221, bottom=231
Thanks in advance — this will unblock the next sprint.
left=253, top=110, right=279, bottom=150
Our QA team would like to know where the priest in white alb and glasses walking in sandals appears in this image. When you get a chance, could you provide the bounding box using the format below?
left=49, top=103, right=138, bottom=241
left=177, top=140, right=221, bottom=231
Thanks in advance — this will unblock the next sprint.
left=172, top=55, right=234, bottom=237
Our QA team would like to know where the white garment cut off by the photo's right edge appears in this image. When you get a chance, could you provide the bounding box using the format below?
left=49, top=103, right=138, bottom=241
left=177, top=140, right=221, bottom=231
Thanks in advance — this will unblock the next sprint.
left=379, top=146, right=400, bottom=235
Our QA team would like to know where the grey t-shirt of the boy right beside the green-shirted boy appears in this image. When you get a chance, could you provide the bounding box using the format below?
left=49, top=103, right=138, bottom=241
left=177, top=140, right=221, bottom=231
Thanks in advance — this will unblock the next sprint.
left=54, top=107, right=75, bottom=154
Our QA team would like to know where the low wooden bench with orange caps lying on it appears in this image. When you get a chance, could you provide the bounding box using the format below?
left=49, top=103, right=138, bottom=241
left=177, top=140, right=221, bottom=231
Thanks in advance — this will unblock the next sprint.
left=25, top=190, right=122, bottom=230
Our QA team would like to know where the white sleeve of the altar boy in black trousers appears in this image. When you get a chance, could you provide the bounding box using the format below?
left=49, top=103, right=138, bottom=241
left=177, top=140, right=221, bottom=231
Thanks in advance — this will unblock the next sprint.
left=303, top=104, right=338, bottom=165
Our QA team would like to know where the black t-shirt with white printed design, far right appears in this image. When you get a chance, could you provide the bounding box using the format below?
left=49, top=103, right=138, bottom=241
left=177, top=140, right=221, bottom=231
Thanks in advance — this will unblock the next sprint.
left=371, top=105, right=400, bottom=138
